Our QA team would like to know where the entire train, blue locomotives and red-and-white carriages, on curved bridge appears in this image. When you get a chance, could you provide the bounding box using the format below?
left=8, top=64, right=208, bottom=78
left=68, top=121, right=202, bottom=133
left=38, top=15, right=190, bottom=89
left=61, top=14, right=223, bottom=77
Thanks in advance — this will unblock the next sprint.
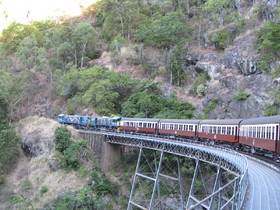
left=57, top=114, right=280, bottom=162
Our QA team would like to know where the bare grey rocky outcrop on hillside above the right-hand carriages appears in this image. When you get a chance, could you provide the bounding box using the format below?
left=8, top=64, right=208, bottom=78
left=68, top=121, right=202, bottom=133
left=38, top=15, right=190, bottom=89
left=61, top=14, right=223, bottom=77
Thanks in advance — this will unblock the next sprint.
left=184, top=16, right=280, bottom=119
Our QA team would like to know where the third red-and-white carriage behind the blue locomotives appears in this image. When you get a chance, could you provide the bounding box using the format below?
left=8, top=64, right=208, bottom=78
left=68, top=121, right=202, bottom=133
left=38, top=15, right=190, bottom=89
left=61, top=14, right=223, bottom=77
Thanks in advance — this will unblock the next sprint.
left=198, top=119, right=241, bottom=143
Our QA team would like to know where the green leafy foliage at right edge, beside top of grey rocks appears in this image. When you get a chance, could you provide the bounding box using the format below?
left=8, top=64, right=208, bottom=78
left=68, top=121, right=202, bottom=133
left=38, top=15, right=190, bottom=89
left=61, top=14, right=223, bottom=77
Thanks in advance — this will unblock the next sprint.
left=257, top=21, right=280, bottom=66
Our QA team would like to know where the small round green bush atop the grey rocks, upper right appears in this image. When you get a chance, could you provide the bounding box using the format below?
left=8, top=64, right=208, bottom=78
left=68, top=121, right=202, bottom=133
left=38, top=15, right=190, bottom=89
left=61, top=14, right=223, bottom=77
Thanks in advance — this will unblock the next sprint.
left=211, top=29, right=232, bottom=50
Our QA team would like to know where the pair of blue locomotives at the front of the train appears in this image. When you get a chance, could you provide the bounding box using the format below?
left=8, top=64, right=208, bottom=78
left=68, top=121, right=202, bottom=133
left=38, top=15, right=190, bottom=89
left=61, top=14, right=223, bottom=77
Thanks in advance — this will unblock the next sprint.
left=57, top=114, right=121, bottom=130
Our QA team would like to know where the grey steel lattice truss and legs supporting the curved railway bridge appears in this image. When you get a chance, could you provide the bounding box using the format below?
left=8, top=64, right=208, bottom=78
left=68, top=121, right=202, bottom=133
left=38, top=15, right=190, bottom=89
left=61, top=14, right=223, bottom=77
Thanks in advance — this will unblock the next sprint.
left=103, top=133, right=248, bottom=209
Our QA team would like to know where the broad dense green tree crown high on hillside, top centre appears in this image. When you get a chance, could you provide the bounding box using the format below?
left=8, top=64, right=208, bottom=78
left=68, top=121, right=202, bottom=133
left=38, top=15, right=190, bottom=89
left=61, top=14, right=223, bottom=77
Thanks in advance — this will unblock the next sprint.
left=135, top=12, right=188, bottom=48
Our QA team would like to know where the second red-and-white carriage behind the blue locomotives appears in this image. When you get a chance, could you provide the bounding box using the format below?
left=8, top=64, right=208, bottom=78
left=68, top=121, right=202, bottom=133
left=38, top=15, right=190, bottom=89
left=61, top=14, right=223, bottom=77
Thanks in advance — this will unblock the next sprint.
left=158, top=119, right=200, bottom=136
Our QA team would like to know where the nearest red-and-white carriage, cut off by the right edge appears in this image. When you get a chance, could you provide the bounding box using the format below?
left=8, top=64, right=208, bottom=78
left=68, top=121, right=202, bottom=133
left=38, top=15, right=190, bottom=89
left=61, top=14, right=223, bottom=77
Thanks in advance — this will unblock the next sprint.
left=239, top=115, right=280, bottom=153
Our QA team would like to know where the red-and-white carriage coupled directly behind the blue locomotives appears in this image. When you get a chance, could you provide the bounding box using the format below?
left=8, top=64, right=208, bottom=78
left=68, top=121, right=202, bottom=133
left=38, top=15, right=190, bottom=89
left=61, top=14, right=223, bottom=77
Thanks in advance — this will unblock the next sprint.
left=120, top=118, right=159, bottom=133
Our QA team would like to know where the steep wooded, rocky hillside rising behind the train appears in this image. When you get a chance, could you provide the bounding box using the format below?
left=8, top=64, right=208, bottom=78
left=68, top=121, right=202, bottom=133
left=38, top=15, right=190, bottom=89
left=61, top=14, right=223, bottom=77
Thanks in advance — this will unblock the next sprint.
left=2, top=0, right=279, bottom=119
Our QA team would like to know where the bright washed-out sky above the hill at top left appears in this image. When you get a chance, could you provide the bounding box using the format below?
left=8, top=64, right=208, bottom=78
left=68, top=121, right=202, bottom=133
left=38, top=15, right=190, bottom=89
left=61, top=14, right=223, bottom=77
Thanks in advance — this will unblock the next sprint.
left=0, top=0, right=97, bottom=32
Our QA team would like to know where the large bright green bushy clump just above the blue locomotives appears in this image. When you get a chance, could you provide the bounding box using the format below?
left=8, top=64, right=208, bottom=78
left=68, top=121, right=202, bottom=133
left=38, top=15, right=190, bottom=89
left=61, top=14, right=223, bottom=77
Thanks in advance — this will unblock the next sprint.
left=60, top=66, right=137, bottom=115
